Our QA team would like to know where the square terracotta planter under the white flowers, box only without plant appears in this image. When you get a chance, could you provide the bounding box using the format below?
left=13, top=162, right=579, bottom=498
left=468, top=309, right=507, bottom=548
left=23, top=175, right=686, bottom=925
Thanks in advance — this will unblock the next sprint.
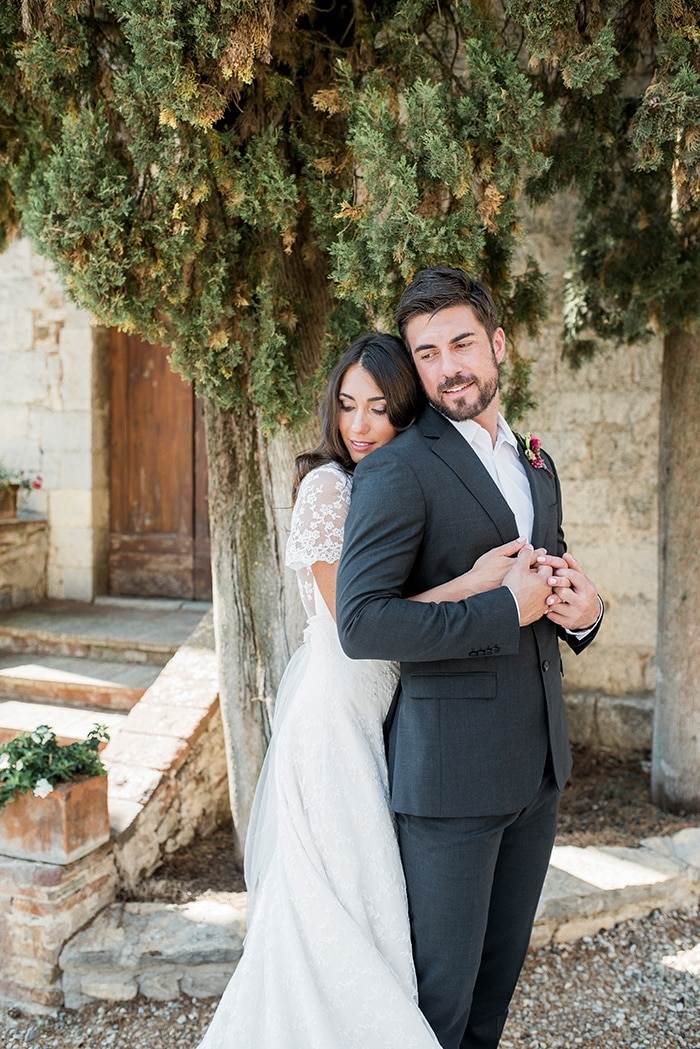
left=0, top=776, right=109, bottom=864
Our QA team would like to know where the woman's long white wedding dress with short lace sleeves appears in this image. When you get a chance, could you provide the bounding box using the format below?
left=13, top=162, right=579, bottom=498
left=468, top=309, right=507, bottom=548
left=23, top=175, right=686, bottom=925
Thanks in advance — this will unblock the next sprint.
left=199, top=465, right=439, bottom=1049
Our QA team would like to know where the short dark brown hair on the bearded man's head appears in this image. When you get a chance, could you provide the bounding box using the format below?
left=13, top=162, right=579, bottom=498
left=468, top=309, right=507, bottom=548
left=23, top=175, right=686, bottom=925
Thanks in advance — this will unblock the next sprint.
left=397, top=265, right=499, bottom=345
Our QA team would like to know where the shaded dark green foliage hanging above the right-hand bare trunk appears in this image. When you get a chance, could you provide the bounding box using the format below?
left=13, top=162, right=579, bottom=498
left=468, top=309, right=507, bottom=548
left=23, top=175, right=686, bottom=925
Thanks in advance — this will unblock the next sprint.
left=518, top=0, right=700, bottom=363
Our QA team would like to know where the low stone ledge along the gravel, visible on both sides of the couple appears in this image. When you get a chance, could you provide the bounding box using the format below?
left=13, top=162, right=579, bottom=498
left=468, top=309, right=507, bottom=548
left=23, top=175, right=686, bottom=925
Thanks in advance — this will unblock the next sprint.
left=60, top=830, right=700, bottom=1008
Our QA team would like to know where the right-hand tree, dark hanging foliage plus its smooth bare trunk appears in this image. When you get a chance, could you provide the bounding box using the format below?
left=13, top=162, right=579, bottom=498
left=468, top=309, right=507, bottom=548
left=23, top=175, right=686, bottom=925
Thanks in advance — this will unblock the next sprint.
left=507, top=0, right=700, bottom=812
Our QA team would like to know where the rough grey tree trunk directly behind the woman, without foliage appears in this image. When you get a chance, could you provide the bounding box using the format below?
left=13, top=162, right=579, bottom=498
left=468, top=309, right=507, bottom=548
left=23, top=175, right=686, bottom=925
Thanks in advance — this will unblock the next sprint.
left=205, top=401, right=310, bottom=865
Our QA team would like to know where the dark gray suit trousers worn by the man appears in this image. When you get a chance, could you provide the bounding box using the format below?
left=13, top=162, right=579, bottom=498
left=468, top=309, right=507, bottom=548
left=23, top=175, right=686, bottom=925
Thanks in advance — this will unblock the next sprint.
left=397, top=762, right=559, bottom=1049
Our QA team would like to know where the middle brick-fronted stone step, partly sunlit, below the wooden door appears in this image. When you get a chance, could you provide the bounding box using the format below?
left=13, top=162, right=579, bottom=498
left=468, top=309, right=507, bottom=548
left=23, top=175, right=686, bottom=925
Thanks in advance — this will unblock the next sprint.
left=0, top=654, right=161, bottom=711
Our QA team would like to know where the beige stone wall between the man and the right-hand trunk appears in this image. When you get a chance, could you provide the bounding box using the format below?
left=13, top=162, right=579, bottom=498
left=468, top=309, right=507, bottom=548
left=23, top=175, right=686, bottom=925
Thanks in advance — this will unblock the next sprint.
left=516, top=197, right=662, bottom=704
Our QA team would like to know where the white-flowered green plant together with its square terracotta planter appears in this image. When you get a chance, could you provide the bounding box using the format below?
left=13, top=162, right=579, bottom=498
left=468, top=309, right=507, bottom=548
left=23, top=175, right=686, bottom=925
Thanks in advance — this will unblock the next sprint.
left=0, top=725, right=109, bottom=864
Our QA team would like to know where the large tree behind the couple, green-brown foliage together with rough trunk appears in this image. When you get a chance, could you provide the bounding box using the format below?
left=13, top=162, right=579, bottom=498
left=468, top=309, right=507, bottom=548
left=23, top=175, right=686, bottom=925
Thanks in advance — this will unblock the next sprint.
left=0, top=0, right=550, bottom=854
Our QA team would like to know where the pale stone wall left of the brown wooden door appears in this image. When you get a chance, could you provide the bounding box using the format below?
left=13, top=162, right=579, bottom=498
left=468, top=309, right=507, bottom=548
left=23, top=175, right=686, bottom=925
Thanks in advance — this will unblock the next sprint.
left=0, top=240, right=108, bottom=600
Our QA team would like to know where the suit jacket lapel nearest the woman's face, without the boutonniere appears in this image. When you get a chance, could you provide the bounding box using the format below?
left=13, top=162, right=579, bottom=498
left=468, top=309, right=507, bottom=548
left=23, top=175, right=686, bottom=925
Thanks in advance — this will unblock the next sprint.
left=417, top=406, right=520, bottom=542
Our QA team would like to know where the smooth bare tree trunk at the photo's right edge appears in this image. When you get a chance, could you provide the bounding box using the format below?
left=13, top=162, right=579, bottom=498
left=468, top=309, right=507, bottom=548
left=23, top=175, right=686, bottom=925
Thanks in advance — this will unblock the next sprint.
left=652, top=331, right=700, bottom=812
